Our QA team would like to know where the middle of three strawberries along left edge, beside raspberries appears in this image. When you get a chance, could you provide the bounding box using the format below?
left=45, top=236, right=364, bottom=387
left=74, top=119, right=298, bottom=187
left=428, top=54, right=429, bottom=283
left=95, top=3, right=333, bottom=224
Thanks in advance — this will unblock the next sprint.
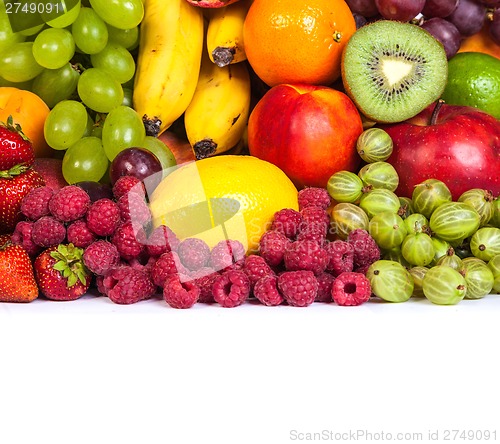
left=0, top=165, right=45, bottom=233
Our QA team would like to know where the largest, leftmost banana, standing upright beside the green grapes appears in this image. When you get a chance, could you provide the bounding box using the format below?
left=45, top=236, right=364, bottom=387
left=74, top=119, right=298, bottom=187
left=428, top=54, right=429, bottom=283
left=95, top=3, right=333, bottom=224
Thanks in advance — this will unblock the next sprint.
left=133, top=0, right=205, bottom=134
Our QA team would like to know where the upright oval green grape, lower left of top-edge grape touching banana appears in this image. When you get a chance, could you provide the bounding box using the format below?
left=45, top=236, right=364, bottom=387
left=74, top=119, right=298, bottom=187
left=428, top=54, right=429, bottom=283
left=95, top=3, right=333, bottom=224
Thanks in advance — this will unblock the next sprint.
left=71, top=7, right=108, bottom=54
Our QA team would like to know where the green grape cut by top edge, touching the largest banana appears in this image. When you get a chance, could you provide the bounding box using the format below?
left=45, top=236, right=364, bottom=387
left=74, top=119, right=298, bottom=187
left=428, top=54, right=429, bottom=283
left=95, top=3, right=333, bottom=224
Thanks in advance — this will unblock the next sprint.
left=90, top=0, right=144, bottom=29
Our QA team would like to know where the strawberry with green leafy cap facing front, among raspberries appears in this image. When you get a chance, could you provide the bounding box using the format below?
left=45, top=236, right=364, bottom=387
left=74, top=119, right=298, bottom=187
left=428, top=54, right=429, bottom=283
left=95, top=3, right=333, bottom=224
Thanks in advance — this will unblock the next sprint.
left=34, top=244, right=92, bottom=301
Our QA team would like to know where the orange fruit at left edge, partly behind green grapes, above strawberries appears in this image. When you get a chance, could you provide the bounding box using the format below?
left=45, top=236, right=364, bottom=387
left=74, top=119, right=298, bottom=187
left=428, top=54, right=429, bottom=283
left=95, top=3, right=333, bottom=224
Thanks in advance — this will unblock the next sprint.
left=0, top=86, right=54, bottom=157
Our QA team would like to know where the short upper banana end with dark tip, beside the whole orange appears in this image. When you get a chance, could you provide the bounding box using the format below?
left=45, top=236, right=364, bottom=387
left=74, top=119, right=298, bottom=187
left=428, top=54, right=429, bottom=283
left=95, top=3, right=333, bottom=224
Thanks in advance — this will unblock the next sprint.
left=207, top=0, right=253, bottom=66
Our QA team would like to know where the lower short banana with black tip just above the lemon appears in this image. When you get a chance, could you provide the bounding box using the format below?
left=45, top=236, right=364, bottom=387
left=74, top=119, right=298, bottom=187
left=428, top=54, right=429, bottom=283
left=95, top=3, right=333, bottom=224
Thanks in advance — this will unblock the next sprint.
left=184, top=51, right=250, bottom=159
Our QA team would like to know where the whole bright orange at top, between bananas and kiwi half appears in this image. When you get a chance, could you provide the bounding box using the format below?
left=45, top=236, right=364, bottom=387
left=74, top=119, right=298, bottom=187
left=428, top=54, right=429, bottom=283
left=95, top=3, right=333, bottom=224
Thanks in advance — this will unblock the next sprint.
left=243, top=0, right=356, bottom=86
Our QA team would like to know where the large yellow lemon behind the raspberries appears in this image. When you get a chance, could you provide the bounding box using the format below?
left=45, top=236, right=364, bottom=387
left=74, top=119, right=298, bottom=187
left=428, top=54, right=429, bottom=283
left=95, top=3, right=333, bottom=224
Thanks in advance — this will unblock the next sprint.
left=150, top=155, right=298, bottom=253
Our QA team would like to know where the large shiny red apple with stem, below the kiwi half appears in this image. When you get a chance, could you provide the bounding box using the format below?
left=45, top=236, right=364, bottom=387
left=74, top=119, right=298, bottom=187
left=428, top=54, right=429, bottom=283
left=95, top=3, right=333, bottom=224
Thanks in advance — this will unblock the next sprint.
left=383, top=101, right=500, bottom=200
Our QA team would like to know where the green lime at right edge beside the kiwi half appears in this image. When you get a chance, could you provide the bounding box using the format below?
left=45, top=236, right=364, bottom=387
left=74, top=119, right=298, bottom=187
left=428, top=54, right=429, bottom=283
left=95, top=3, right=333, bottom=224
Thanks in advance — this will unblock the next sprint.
left=442, top=52, right=500, bottom=119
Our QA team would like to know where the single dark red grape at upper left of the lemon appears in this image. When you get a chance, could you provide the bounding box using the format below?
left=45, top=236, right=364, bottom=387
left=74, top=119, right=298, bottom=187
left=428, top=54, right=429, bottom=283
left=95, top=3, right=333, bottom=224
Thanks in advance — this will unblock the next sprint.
left=109, top=148, right=162, bottom=188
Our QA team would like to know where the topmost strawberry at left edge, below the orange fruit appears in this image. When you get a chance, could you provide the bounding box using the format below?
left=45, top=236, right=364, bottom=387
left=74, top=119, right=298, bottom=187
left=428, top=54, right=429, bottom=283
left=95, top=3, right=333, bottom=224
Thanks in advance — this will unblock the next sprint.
left=0, top=116, right=35, bottom=171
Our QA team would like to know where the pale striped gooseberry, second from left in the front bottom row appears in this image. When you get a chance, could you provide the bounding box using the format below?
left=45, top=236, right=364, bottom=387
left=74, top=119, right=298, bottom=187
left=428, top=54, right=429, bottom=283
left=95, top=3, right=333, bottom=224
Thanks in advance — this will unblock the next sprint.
left=422, top=265, right=467, bottom=305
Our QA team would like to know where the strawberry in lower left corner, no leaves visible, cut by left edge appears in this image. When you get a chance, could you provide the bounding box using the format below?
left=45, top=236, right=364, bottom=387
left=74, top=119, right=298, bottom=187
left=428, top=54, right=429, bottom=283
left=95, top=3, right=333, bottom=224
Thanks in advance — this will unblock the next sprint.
left=0, top=236, right=38, bottom=302
